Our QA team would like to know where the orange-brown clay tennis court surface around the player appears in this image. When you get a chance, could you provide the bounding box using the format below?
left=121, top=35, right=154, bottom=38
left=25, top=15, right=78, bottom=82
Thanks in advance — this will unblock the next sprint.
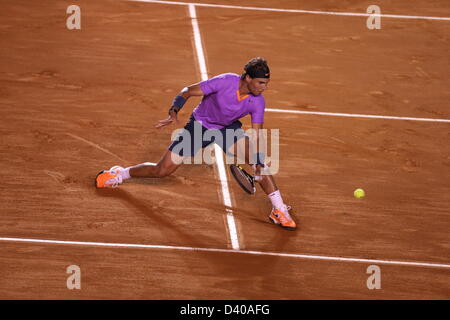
left=0, top=0, right=450, bottom=299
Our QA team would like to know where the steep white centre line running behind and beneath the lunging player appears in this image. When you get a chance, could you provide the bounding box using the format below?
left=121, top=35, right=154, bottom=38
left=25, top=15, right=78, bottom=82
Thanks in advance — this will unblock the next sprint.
left=189, top=4, right=239, bottom=250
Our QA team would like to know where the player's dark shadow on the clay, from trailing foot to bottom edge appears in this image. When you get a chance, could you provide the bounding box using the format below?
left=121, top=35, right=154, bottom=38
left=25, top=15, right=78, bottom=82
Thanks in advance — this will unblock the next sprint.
left=96, top=189, right=298, bottom=299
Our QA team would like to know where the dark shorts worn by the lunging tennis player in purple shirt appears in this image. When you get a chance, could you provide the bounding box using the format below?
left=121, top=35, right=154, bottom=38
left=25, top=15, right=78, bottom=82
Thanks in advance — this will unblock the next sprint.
left=169, top=115, right=246, bottom=157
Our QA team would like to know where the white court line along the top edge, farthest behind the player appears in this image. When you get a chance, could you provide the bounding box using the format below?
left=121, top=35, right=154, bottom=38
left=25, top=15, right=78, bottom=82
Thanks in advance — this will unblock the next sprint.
left=128, top=0, right=450, bottom=21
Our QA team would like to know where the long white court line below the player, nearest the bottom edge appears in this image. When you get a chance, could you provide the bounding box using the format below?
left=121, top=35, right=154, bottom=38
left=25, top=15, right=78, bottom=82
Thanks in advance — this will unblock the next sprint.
left=0, top=238, right=450, bottom=269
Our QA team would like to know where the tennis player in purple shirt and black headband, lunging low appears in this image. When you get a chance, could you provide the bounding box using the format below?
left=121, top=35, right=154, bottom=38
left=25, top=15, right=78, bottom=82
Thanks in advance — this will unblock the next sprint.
left=95, top=57, right=296, bottom=230
